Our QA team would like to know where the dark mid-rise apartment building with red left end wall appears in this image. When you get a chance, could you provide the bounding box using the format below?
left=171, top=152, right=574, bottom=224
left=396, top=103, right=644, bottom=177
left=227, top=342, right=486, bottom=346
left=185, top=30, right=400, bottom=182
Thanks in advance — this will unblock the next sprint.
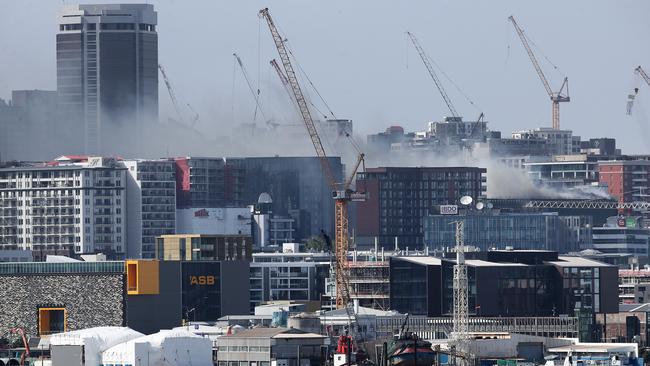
left=175, top=157, right=244, bottom=209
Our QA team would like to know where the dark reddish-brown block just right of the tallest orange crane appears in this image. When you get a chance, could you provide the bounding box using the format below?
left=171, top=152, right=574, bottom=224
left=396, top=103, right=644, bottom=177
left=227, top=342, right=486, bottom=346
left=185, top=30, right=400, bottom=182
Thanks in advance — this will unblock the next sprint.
left=355, top=167, right=487, bottom=249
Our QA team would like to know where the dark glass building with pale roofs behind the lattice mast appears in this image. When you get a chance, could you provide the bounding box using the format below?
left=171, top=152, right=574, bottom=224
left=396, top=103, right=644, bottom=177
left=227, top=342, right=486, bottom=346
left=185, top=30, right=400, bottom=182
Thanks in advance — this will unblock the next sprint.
left=390, top=250, right=618, bottom=316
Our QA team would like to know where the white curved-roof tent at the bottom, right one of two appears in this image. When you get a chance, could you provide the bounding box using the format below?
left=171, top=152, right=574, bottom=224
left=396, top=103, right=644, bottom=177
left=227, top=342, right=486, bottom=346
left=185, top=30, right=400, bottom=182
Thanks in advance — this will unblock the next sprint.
left=101, top=329, right=212, bottom=366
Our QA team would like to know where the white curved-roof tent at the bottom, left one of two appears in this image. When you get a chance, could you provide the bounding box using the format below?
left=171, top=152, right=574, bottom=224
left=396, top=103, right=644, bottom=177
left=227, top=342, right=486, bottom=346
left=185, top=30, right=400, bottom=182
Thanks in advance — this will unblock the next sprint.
left=50, top=327, right=143, bottom=365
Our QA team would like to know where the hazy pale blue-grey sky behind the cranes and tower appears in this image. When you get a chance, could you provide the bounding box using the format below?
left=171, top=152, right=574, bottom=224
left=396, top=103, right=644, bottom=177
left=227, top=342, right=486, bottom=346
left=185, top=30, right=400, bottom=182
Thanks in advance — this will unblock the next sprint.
left=0, top=0, right=650, bottom=153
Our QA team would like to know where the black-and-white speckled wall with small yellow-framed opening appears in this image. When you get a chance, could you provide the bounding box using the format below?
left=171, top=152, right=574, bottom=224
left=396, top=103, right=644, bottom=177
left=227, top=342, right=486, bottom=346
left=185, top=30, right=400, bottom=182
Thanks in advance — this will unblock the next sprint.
left=0, top=274, right=125, bottom=335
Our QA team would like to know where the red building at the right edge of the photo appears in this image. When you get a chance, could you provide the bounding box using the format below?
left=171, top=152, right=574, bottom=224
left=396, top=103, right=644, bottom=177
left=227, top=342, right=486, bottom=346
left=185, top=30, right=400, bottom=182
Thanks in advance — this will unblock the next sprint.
left=598, top=160, right=650, bottom=202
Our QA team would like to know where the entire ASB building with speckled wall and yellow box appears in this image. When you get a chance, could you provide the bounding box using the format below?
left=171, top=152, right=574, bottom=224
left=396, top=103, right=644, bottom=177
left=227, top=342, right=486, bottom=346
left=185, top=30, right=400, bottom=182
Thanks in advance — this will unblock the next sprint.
left=0, top=260, right=249, bottom=335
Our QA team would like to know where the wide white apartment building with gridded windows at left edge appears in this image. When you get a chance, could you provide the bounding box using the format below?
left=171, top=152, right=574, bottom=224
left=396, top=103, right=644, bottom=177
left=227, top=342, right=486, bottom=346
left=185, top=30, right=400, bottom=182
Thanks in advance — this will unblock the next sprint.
left=0, top=157, right=127, bottom=259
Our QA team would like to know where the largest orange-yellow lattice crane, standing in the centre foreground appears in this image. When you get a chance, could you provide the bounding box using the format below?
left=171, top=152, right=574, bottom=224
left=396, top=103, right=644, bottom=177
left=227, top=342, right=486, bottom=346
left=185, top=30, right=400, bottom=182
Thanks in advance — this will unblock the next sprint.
left=259, top=8, right=365, bottom=316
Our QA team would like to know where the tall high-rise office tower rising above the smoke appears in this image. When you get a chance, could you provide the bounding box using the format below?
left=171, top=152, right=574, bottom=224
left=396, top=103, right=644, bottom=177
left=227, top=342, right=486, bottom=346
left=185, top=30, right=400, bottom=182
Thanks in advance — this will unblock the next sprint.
left=56, top=4, right=158, bottom=154
